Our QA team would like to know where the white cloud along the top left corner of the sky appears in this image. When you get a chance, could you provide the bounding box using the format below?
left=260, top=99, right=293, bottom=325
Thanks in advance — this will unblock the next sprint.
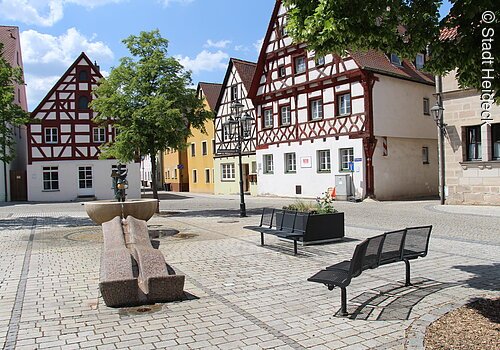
left=0, top=0, right=124, bottom=27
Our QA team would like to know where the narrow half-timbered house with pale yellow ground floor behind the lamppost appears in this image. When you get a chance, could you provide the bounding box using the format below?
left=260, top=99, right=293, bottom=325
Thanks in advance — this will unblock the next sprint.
left=214, top=58, right=257, bottom=195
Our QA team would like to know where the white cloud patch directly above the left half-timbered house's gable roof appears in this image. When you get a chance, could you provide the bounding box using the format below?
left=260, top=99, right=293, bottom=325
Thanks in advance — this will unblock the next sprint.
left=21, top=28, right=114, bottom=110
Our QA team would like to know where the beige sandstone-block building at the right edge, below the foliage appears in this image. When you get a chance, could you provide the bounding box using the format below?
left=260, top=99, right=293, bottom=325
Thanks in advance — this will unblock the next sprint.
left=443, top=72, right=500, bottom=205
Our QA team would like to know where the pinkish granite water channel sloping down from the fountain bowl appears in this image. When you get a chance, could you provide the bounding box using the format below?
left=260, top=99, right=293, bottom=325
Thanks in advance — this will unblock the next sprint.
left=99, top=216, right=185, bottom=307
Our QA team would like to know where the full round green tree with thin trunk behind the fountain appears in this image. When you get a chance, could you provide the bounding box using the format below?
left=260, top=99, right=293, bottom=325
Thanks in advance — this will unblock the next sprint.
left=91, top=30, right=212, bottom=199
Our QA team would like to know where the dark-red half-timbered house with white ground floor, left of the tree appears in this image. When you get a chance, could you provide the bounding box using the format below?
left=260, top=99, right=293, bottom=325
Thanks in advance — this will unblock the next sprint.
left=27, top=52, right=140, bottom=201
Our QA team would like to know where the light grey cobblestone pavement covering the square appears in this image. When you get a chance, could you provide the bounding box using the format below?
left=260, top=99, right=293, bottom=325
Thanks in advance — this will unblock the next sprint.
left=0, top=193, right=500, bottom=349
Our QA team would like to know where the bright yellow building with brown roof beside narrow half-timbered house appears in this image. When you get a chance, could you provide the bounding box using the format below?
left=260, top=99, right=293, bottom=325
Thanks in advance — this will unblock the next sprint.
left=187, top=83, right=222, bottom=193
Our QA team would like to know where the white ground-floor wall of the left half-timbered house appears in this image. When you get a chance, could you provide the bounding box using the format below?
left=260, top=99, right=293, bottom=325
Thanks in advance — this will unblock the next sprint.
left=27, top=160, right=141, bottom=202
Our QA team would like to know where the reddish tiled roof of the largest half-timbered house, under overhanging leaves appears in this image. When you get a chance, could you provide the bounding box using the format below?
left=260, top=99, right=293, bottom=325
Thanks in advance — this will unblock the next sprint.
left=350, top=50, right=434, bottom=84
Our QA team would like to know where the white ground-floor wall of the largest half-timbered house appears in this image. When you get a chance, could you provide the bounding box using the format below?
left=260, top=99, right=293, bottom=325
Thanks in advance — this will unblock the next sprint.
left=257, top=137, right=365, bottom=198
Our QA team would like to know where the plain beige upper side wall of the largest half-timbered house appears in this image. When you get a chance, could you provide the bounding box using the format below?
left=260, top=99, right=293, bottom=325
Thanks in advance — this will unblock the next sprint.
left=373, top=75, right=437, bottom=139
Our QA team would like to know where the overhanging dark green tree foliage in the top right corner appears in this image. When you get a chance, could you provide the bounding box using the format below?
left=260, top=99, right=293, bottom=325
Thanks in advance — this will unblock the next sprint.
left=283, top=0, right=500, bottom=102
